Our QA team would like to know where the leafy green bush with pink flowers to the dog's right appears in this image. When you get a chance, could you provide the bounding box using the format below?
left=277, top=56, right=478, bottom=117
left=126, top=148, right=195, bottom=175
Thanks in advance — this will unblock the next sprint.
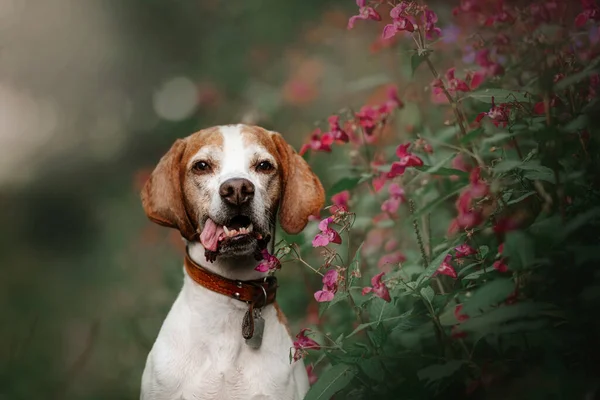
left=264, top=0, right=600, bottom=399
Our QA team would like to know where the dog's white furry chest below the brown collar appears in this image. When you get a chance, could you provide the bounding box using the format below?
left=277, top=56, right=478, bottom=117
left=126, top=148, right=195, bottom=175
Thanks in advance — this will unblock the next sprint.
left=141, top=277, right=308, bottom=400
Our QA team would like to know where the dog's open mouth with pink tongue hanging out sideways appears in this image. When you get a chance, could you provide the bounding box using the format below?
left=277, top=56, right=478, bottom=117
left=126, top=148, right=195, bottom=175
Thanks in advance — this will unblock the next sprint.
left=200, top=215, right=263, bottom=252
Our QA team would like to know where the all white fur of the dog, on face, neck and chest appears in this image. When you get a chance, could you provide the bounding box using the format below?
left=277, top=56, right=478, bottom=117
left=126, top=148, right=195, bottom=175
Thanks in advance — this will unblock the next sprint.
left=141, top=126, right=309, bottom=400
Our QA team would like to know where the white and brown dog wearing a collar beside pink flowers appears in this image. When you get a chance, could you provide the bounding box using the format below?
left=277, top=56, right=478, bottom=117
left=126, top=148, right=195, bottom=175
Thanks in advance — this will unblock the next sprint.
left=141, top=125, right=325, bottom=400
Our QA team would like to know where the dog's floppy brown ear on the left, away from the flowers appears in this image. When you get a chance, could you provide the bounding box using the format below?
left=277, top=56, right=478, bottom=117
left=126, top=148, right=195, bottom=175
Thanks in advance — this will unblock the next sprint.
left=142, top=139, right=196, bottom=240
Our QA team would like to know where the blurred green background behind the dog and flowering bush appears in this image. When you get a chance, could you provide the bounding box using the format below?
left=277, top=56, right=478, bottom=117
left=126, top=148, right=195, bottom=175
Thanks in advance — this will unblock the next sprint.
left=0, top=0, right=420, bottom=399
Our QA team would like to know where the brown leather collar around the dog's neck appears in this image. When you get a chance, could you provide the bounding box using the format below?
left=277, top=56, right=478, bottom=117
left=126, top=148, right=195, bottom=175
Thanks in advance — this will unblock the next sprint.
left=184, top=249, right=277, bottom=308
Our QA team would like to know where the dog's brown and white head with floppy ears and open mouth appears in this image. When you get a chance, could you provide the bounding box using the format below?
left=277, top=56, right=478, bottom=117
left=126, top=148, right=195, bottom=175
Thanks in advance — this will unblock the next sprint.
left=142, top=125, right=325, bottom=256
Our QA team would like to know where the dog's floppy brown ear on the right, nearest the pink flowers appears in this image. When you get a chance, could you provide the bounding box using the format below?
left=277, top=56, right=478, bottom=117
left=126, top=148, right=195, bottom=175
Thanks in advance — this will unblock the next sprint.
left=272, top=133, right=325, bottom=234
